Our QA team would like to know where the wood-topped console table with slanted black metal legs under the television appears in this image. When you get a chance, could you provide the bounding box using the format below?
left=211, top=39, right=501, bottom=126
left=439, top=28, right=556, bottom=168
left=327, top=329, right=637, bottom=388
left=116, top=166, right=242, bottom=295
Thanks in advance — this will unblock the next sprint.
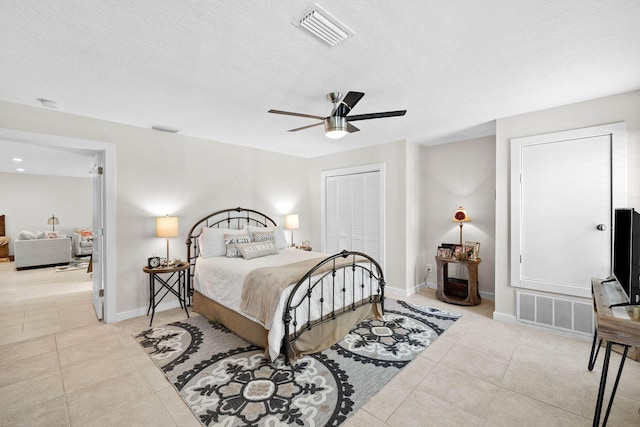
left=588, top=278, right=640, bottom=427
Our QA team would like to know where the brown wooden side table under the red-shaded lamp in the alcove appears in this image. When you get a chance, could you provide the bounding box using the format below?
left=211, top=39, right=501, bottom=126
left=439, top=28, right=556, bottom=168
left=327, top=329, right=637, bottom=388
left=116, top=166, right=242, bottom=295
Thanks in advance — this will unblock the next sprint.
left=436, top=256, right=482, bottom=305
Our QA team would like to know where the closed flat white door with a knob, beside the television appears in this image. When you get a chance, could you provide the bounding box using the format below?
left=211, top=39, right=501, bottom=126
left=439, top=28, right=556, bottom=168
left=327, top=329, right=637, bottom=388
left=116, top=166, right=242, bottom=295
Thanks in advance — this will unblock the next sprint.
left=511, top=123, right=619, bottom=298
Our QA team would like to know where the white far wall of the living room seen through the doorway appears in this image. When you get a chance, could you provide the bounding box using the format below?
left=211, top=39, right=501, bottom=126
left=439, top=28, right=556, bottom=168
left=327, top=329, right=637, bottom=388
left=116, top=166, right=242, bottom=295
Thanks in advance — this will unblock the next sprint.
left=0, top=173, right=93, bottom=255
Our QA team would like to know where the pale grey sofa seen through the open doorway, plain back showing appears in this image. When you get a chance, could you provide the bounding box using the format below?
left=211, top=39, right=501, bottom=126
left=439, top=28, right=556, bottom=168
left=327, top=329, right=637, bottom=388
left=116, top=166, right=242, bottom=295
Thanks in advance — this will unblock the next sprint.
left=13, top=236, right=71, bottom=270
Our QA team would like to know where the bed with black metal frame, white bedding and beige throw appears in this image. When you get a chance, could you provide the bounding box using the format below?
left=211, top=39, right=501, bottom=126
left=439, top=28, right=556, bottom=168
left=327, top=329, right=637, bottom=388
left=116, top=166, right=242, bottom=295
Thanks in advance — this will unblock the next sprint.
left=186, top=207, right=385, bottom=364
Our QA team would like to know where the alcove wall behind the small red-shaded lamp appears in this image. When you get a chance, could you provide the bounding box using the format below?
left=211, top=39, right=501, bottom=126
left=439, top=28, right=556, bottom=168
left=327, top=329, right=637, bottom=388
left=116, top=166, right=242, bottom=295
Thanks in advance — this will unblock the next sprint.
left=416, top=137, right=495, bottom=296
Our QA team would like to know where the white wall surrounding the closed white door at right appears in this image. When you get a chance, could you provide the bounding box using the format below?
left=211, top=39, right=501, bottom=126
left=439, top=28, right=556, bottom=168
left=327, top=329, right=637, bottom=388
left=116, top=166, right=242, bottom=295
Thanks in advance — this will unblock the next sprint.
left=494, top=91, right=640, bottom=319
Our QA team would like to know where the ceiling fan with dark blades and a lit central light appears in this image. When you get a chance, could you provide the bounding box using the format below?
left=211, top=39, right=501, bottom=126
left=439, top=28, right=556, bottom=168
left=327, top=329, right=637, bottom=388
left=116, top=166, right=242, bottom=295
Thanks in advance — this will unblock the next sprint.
left=269, top=92, right=407, bottom=138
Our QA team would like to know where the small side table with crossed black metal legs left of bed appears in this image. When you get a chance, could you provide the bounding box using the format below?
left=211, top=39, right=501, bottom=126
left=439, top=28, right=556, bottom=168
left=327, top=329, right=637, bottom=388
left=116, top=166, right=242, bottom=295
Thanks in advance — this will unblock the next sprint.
left=142, top=262, right=190, bottom=326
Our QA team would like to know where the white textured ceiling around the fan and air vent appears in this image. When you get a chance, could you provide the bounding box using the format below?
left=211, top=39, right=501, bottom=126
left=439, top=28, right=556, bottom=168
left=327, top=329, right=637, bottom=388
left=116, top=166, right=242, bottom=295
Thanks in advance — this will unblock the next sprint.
left=0, top=0, right=640, bottom=176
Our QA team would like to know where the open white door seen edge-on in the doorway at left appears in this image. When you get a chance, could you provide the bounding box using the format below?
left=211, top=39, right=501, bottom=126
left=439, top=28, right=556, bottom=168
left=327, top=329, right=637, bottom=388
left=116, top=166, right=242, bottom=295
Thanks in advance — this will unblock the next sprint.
left=91, top=151, right=104, bottom=320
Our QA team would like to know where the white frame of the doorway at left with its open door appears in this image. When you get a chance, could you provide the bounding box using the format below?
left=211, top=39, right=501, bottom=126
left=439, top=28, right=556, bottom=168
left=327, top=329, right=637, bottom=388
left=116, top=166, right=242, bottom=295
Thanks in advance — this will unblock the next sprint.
left=0, top=129, right=116, bottom=328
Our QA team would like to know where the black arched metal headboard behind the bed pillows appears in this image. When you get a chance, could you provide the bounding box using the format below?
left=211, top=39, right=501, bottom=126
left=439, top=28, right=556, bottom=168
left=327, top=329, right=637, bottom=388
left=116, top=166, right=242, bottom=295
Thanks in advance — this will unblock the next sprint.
left=185, top=207, right=277, bottom=297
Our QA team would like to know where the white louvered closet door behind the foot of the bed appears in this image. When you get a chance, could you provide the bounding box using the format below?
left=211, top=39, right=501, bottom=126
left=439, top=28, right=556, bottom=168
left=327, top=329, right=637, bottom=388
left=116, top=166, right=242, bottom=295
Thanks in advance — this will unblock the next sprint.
left=325, top=171, right=383, bottom=263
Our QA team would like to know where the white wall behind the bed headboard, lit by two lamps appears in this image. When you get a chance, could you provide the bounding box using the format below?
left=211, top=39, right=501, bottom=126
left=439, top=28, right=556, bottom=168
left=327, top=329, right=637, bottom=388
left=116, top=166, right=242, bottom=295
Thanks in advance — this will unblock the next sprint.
left=0, top=102, right=310, bottom=321
